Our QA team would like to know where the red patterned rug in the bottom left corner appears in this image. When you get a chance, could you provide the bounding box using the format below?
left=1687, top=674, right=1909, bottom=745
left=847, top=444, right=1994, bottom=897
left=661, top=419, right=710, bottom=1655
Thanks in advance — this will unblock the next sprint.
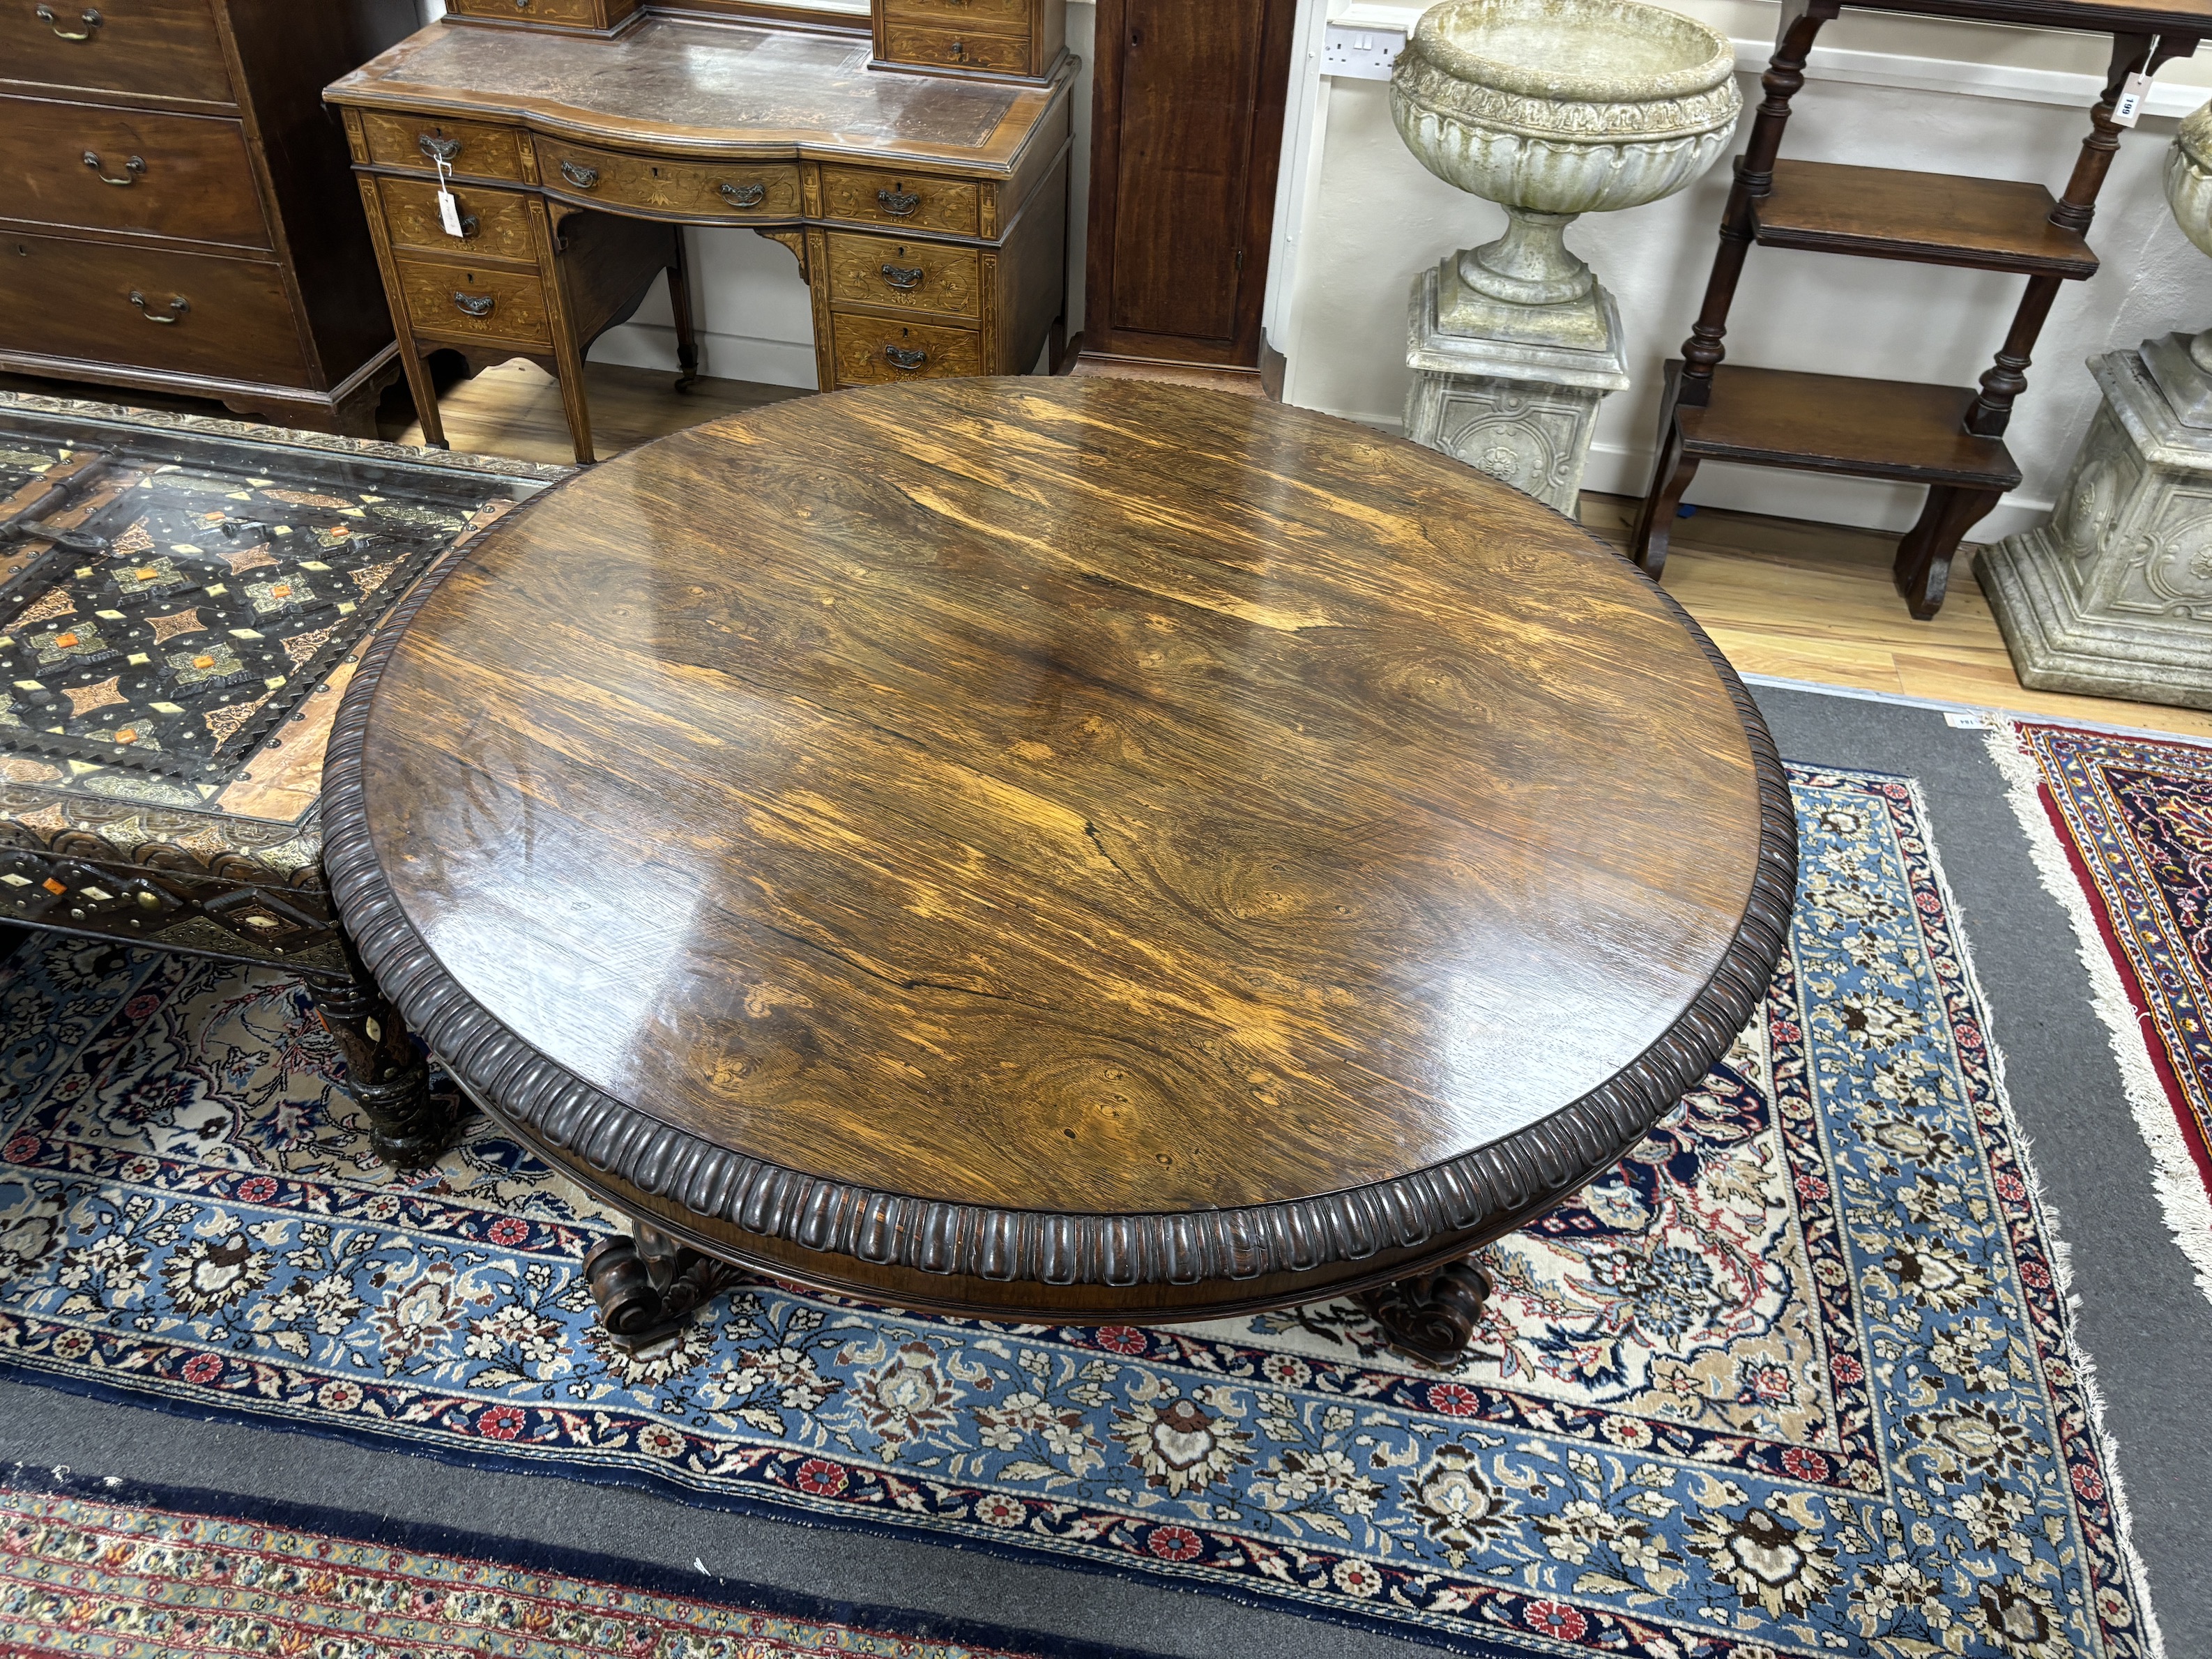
left=0, top=1471, right=1139, bottom=1659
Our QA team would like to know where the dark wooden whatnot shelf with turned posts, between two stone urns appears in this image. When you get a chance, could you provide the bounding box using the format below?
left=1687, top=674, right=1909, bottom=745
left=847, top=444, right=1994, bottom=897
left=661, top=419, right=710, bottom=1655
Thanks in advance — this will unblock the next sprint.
left=1628, top=0, right=2212, bottom=620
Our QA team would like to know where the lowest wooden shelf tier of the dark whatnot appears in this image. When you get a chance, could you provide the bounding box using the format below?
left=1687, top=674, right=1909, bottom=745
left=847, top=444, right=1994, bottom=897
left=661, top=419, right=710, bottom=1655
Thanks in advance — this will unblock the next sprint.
left=1668, top=360, right=2020, bottom=491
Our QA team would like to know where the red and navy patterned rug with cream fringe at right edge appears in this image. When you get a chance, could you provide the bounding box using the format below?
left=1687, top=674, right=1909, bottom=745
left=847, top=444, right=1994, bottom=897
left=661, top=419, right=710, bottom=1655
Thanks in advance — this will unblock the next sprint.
left=1991, top=721, right=2212, bottom=1297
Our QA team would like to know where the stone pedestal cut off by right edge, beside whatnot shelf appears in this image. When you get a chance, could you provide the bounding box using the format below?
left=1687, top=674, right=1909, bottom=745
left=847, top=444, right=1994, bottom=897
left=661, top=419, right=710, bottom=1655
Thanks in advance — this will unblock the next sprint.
left=1973, top=347, right=2212, bottom=708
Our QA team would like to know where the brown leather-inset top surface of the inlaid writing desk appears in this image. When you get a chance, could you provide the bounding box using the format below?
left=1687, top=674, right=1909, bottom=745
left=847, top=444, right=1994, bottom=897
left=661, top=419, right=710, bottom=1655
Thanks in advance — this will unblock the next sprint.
left=328, top=17, right=1073, bottom=173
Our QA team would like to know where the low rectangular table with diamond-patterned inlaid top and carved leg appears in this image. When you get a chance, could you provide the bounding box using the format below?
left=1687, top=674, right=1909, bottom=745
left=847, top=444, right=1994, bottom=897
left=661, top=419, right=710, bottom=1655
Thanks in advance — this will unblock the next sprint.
left=0, top=392, right=571, bottom=1165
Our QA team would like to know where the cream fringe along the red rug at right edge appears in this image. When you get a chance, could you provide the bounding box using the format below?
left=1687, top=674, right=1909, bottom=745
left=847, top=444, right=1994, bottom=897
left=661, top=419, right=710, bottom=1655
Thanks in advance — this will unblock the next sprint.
left=1989, top=719, right=2212, bottom=1299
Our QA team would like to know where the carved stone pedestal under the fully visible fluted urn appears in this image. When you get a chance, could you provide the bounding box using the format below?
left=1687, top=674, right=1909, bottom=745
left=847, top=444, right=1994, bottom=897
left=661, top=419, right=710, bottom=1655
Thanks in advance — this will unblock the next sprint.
left=1405, top=259, right=1628, bottom=518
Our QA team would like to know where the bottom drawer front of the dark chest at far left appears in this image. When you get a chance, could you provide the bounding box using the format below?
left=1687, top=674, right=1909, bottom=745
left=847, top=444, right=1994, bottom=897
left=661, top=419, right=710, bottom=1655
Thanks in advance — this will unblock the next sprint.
left=0, top=234, right=307, bottom=385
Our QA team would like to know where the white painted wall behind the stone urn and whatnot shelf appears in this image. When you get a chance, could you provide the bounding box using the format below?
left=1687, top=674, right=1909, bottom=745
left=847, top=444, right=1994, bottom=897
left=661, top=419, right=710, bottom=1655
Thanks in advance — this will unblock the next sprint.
left=1269, top=0, right=2212, bottom=537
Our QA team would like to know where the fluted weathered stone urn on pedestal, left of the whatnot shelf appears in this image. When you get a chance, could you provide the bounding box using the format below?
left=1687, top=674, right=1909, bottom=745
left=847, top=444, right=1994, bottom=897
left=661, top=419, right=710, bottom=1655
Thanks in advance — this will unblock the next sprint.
left=1389, top=0, right=1743, bottom=305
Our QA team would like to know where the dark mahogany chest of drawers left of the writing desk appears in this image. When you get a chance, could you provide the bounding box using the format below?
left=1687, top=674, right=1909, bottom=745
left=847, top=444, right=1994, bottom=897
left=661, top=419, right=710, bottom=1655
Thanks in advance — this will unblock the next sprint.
left=0, top=0, right=416, bottom=436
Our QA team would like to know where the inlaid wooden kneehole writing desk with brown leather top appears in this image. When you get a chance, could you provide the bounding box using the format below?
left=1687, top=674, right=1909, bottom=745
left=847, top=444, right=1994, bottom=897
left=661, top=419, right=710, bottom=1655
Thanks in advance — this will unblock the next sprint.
left=325, top=13, right=1075, bottom=462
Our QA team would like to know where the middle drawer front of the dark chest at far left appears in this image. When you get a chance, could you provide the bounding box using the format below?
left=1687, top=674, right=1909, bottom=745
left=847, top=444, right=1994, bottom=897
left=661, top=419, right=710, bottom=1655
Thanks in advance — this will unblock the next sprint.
left=0, top=98, right=270, bottom=247
